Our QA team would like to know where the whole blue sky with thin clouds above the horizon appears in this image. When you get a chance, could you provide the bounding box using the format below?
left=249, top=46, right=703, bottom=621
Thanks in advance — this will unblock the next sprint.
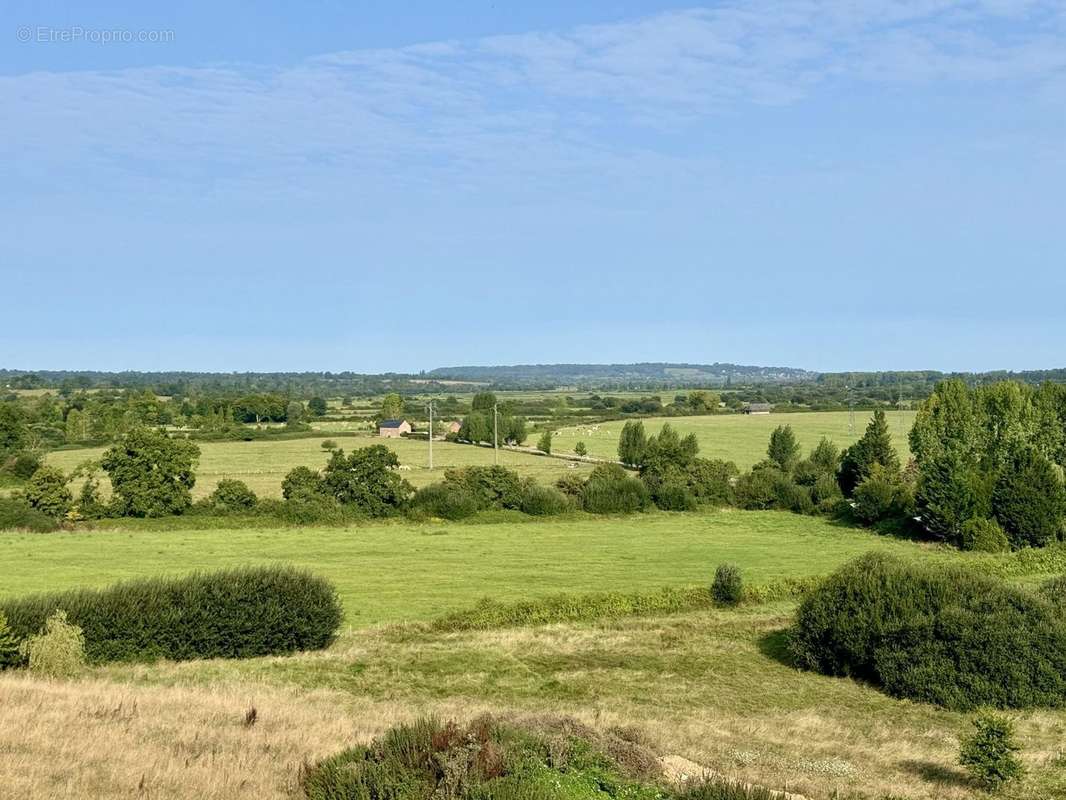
left=0, top=0, right=1066, bottom=371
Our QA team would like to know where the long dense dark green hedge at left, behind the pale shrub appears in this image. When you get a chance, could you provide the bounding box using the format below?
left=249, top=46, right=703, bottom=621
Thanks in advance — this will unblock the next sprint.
left=0, top=566, right=341, bottom=662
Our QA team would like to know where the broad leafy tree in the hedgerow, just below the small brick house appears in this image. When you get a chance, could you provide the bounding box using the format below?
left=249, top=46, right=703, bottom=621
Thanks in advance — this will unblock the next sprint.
left=322, top=445, right=414, bottom=516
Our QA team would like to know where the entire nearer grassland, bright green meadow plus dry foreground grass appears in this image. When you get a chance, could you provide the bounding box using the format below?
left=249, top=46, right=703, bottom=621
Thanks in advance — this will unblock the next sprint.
left=6, top=511, right=1066, bottom=800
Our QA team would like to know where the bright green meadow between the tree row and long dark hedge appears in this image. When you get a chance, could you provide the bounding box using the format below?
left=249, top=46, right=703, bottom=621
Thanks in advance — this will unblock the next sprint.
left=0, top=511, right=963, bottom=627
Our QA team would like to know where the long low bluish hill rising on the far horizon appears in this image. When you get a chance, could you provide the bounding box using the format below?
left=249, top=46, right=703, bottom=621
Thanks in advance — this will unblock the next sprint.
left=426, top=362, right=805, bottom=387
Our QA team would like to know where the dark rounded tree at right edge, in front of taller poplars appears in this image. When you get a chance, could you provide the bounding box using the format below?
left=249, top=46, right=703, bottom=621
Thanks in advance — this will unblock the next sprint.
left=992, top=449, right=1066, bottom=547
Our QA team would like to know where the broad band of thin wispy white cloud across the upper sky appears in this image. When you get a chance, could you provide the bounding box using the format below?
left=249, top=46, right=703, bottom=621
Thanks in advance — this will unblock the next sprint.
left=0, top=0, right=1066, bottom=197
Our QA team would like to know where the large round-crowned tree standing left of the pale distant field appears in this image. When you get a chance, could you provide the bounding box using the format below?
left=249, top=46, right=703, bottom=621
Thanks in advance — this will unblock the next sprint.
left=100, top=428, right=199, bottom=516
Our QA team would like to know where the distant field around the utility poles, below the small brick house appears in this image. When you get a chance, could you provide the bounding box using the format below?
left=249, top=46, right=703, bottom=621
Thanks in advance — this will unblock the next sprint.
left=48, top=435, right=592, bottom=497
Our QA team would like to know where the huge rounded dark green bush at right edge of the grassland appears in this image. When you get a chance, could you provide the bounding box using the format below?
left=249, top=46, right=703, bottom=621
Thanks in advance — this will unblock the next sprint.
left=790, top=554, right=1066, bottom=709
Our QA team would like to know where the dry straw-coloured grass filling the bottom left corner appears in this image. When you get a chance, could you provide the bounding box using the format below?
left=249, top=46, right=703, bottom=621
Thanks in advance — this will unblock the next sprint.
left=0, top=675, right=490, bottom=800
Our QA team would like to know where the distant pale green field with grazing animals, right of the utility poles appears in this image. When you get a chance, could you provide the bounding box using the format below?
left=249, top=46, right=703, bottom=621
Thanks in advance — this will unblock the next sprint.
left=552, top=411, right=915, bottom=469
